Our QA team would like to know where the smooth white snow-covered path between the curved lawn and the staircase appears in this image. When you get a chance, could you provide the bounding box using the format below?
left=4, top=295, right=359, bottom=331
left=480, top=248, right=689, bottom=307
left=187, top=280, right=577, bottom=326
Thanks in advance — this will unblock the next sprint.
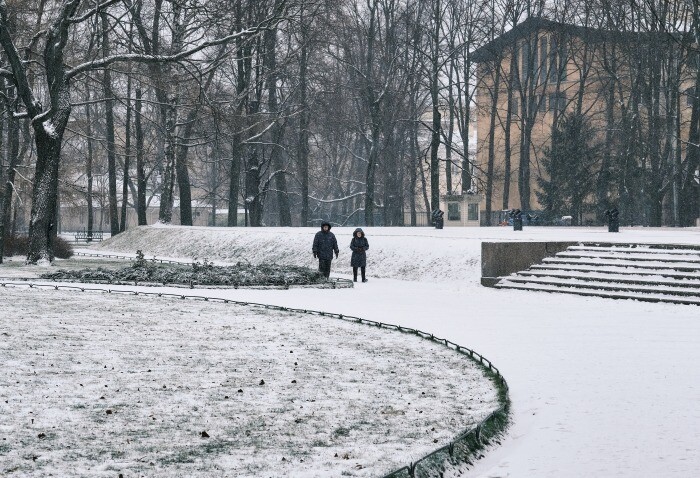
left=175, top=279, right=700, bottom=478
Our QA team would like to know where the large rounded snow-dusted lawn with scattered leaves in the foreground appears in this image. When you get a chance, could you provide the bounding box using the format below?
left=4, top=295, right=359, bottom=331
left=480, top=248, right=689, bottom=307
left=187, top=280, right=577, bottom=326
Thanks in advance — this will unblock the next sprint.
left=0, top=286, right=498, bottom=477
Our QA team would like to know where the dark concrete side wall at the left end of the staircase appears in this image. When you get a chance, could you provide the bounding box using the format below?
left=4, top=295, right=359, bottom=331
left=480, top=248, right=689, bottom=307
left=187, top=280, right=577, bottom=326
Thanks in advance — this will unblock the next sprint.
left=481, top=242, right=578, bottom=287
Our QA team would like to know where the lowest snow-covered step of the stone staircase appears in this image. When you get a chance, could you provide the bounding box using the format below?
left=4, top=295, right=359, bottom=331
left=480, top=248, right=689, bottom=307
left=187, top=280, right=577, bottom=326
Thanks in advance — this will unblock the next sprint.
left=506, top=276, right=700, bottom=299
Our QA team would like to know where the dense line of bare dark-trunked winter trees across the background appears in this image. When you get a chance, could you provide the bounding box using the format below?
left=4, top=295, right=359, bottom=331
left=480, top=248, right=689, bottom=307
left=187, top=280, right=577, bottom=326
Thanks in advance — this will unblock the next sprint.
left=0, top=0, right=700, bottom=262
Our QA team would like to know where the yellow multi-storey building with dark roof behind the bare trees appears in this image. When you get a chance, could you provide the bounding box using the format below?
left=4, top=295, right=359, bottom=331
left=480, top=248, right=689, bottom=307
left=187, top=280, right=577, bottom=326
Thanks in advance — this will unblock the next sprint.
left=473, top=18, right=696, bottom=225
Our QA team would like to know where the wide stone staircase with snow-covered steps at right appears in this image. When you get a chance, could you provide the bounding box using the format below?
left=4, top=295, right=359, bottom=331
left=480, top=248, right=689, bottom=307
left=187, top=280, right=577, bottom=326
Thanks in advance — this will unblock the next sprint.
left=495, top=243, right=700, bottom=305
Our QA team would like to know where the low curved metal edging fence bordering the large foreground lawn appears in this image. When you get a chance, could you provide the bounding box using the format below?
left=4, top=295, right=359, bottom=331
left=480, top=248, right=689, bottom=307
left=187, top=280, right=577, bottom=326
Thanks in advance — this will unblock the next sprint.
left=0, top=270, right=510, bottom=478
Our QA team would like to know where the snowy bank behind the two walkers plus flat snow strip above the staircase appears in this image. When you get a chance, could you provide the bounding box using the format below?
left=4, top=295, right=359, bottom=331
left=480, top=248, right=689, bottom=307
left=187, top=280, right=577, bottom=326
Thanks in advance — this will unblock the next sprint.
left=91, top=225, right=700, bottom=282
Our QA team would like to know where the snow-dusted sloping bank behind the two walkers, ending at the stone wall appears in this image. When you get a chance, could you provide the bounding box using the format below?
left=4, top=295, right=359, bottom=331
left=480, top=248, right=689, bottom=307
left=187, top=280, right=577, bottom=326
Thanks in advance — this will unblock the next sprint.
left=92, top=226, right=481, bottom=281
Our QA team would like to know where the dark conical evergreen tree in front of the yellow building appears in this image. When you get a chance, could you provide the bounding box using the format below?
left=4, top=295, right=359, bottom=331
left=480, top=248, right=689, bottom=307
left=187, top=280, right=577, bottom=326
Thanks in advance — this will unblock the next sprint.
left=537, top=113, right=600, bottom=225
